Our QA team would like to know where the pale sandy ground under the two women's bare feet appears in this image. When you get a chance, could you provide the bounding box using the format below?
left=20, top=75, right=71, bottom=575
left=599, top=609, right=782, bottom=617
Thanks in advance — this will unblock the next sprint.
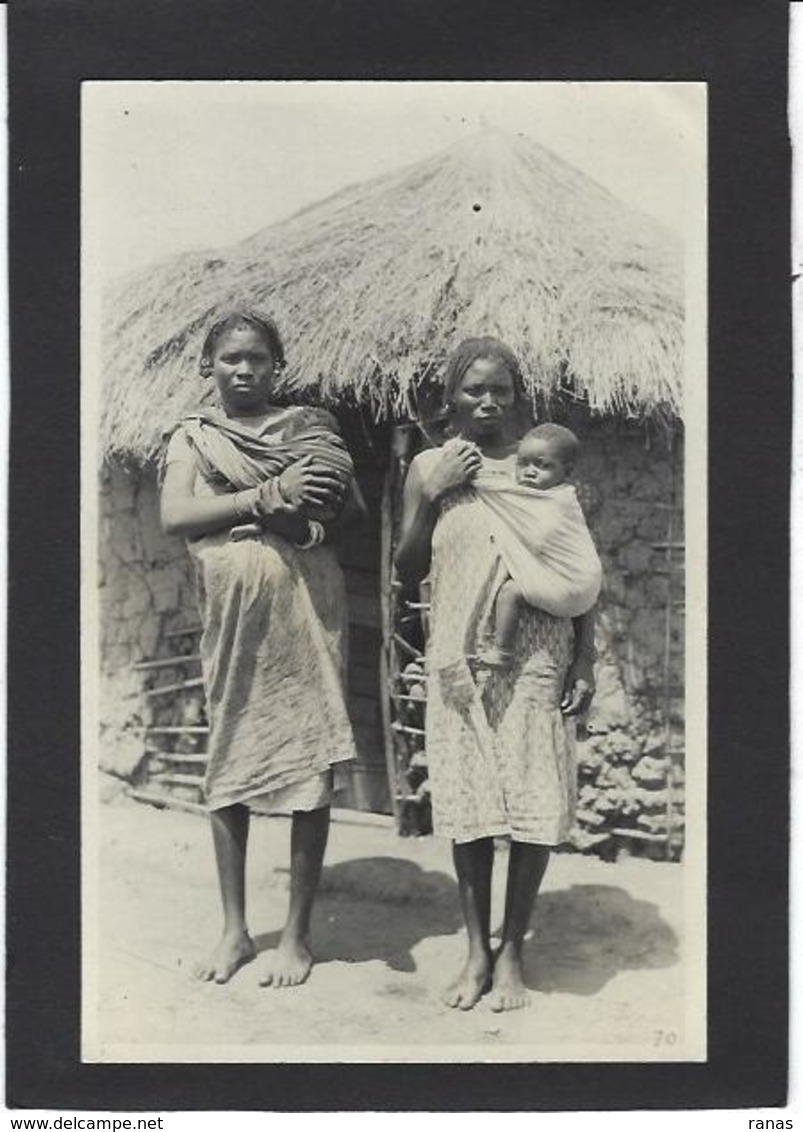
left=85, top=797, right=684, bottom=1061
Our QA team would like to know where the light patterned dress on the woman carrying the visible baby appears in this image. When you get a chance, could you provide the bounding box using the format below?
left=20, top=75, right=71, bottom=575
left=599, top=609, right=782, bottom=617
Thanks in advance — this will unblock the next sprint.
left=419, top=453, right=576, bottom=846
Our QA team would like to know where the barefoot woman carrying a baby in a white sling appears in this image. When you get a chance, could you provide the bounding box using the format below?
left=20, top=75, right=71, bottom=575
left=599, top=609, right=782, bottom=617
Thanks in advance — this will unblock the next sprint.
left=396, top=337, right=595, bottom=1011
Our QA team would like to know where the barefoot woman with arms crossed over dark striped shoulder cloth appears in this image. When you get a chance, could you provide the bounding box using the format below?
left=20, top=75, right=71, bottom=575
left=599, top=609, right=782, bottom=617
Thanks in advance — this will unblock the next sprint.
left=162, top=310, right=361, bottom=987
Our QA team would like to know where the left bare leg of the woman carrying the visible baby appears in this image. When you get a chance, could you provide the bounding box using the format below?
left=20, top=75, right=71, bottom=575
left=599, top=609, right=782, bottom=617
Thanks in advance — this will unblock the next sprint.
left=443, top=838, right=494, bottom=1010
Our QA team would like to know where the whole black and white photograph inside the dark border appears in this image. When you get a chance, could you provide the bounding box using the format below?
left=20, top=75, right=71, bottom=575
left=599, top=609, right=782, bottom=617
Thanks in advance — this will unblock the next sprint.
left=80, top=80, right=708, bottom=1063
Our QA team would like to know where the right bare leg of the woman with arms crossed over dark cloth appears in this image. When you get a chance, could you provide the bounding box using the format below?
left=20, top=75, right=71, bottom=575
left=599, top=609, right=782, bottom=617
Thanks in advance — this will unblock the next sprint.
left=259, top=806, right=330, bottom=987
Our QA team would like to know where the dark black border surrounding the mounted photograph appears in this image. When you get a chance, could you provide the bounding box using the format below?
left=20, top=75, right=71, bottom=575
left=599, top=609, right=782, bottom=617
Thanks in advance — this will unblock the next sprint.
left=7, top=0, right=792, bottom=1110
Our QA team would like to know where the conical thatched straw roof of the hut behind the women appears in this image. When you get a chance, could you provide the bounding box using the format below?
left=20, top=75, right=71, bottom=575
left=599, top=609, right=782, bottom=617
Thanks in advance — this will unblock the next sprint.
left=96, top=130, right=683, bottom=458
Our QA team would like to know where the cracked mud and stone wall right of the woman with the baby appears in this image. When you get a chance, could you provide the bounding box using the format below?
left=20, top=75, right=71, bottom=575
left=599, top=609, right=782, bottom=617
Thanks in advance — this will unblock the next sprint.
left=573, top=421, right=684, bottom=857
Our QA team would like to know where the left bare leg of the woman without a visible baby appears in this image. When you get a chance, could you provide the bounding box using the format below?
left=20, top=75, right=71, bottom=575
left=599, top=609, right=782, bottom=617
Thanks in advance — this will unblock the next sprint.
left=195, top=805, right=255, bottom=983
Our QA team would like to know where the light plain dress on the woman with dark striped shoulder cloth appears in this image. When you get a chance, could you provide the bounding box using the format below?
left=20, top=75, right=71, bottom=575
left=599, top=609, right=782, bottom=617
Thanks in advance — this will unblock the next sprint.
left=165, top=411, right=354, bottom=813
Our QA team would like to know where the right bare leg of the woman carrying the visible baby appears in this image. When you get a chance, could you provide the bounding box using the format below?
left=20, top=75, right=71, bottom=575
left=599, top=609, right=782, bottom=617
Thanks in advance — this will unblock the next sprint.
left=490, top=841, right=549, bottom=1011
